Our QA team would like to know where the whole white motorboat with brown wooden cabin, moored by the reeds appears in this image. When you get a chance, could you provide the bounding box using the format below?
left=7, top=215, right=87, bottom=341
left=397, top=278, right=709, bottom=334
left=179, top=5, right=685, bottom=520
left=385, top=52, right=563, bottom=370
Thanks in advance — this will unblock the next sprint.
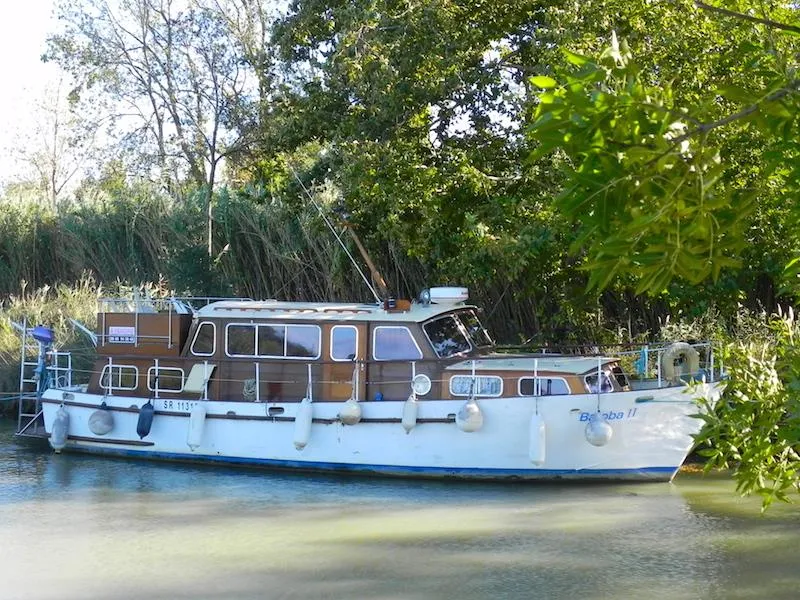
left=18, top=288, right=721, bottom=481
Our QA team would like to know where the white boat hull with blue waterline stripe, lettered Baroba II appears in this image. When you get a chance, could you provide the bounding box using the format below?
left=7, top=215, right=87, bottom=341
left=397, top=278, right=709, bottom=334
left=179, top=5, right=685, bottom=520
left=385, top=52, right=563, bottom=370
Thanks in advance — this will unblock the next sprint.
left=43, top=384, right=719, bottom=481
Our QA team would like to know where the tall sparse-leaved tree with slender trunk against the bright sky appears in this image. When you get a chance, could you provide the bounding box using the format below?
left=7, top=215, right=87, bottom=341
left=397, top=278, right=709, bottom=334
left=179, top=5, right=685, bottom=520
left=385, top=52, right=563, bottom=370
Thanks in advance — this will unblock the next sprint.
left=46, top=0, right=256, bottom=253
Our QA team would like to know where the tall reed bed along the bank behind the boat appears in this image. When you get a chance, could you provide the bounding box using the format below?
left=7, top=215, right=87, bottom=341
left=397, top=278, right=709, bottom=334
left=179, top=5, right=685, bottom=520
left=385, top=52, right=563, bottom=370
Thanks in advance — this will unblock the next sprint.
left=0, top=186, right=688, bottom=366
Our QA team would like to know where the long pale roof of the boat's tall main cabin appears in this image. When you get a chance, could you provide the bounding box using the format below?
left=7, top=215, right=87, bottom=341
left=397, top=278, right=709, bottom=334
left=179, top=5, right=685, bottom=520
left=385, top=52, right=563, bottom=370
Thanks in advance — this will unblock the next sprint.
left=196, top=300, right=475, bottom=323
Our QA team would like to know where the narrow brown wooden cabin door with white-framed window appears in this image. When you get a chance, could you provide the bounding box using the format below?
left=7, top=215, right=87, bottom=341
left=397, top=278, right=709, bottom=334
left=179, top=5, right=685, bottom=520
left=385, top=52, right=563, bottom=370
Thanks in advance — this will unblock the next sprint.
left=321, top=323, right=367, bottom=401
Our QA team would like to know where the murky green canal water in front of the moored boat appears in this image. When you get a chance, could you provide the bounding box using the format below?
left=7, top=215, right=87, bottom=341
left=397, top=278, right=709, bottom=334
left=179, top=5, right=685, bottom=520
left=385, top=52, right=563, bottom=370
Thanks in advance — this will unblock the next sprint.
left=0, top=420, right=800, bottom=600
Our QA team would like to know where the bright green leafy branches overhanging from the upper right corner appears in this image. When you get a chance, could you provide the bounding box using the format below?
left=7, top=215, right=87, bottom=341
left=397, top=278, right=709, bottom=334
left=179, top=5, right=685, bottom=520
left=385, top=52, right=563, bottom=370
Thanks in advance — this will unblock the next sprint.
left=528, top=3, right=800, bottom=293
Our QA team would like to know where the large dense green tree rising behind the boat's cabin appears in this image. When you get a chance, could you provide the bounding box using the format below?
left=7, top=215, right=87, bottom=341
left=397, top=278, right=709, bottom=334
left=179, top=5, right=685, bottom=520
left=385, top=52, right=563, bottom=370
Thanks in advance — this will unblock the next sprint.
left=262, top=0, right=592, bottom=328
